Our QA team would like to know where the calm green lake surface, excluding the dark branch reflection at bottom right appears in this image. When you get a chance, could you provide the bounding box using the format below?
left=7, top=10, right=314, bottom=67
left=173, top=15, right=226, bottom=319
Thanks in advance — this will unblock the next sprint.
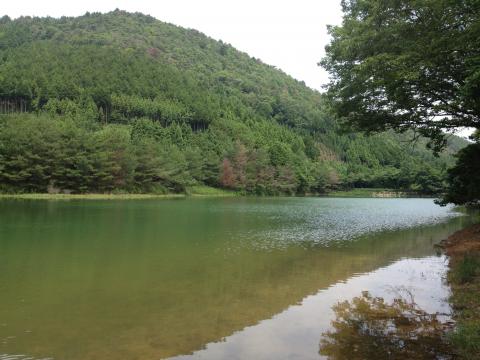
left=0, top=198, right=473, bottom=360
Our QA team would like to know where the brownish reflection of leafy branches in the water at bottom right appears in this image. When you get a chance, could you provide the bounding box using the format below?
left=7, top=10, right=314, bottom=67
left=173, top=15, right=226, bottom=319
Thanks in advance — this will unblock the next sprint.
left=320, top=292, right=453, bottom=360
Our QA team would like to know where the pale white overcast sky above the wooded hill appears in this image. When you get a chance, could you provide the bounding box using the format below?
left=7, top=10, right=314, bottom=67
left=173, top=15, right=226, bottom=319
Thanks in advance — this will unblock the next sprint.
left=0, top=0, right=341, bottom=89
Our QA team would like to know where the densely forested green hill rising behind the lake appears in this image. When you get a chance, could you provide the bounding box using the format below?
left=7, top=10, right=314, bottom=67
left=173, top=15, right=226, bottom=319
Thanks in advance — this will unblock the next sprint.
left=0, top=10, right=464, bottom=194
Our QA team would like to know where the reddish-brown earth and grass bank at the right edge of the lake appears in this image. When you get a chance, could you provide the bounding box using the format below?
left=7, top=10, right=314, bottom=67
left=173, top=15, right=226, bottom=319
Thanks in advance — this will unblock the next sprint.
left=440, top=223, right=480, bottom=359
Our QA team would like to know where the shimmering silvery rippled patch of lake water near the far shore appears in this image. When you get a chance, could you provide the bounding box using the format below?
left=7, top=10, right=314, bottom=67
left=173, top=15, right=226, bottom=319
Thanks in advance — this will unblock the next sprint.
left=212, top=198, right=461, bottom=250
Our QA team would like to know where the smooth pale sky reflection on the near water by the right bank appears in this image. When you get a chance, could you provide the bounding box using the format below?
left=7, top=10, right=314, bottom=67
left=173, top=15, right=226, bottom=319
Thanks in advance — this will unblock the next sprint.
left=174, top=256, right=450, bottom=360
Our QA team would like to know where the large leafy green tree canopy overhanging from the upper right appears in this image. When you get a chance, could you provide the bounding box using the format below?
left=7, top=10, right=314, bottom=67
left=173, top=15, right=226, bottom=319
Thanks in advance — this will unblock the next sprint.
left=321, top=0, right=480, bottom=150
